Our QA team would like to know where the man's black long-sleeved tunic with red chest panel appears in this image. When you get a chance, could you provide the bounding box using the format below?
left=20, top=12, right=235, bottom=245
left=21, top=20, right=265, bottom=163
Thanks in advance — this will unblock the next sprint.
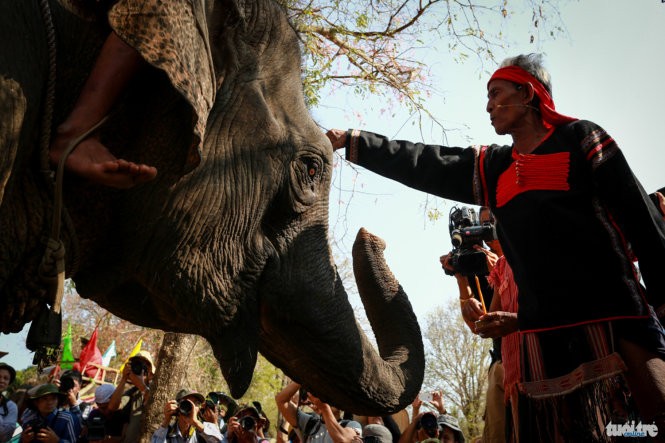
left=346, top=121, right=665, bottom=332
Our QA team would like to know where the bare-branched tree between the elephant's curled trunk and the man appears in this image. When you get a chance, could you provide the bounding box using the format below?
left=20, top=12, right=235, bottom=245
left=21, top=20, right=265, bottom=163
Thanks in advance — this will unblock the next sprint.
left=423, top=300, right=492, bottom=435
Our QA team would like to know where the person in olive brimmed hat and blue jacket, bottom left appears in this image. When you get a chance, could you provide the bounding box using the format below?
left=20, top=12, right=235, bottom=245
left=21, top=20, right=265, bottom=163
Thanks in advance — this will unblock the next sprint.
left=21, top=383, right=81, bottom=443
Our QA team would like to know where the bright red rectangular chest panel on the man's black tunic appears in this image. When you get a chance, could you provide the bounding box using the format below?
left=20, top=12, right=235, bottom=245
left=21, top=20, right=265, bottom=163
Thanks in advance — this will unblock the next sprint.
left=496, top=152, right=570, bottom=208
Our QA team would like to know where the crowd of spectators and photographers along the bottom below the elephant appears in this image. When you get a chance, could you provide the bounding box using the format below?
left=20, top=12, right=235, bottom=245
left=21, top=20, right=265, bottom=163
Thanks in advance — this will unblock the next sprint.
left=0, top=351, right=466, bottom=443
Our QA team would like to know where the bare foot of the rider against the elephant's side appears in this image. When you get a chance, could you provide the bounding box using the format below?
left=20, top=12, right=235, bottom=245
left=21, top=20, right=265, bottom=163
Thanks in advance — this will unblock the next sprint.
left=49, top=136, right=157, bottom=189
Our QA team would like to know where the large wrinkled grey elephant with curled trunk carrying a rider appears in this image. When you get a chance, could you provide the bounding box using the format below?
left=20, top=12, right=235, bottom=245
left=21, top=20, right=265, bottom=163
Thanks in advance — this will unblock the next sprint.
left=0, top=0, right=424, bottom=415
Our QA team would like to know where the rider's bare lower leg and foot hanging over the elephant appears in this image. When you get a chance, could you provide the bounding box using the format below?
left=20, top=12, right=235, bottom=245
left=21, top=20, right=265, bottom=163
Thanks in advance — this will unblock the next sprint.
left=49, top=32, right=157, bottom=188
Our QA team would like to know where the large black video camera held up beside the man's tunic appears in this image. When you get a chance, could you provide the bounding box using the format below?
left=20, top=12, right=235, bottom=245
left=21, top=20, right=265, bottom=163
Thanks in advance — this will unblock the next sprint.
left=445, top=206, right=497, bottom=277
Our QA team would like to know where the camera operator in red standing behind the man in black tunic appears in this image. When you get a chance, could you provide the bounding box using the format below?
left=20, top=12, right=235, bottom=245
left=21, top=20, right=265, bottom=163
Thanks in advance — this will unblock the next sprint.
left=440, top=207, right=506, bottom=442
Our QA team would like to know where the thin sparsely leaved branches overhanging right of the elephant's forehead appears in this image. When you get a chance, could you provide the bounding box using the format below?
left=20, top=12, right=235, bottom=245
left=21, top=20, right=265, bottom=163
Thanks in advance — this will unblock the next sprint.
left=279, top=0, right=562, bottom=112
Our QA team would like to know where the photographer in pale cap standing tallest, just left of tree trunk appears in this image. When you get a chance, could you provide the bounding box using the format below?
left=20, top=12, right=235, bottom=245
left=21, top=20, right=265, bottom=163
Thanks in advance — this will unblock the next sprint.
left=109, top=351, right=155, bottom=443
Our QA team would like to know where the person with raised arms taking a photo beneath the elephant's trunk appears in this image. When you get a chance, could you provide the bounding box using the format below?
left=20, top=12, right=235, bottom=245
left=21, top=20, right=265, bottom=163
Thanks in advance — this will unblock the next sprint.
left=275, top=382, right=362, bottom=443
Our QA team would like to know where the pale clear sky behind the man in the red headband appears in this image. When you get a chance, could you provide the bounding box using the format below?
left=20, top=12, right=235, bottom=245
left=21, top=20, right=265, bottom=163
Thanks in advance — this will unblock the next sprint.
left=0, top=0, right=665, bottom=369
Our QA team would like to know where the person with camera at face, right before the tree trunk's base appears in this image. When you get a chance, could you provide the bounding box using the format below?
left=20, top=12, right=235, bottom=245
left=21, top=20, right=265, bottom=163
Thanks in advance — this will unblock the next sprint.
left=151, top=389, right=222, bottom=443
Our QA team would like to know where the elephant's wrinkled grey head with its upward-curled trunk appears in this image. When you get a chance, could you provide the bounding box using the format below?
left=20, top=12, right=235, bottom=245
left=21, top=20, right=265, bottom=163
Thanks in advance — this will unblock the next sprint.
left=0, top=0, right=424, bottom=415
